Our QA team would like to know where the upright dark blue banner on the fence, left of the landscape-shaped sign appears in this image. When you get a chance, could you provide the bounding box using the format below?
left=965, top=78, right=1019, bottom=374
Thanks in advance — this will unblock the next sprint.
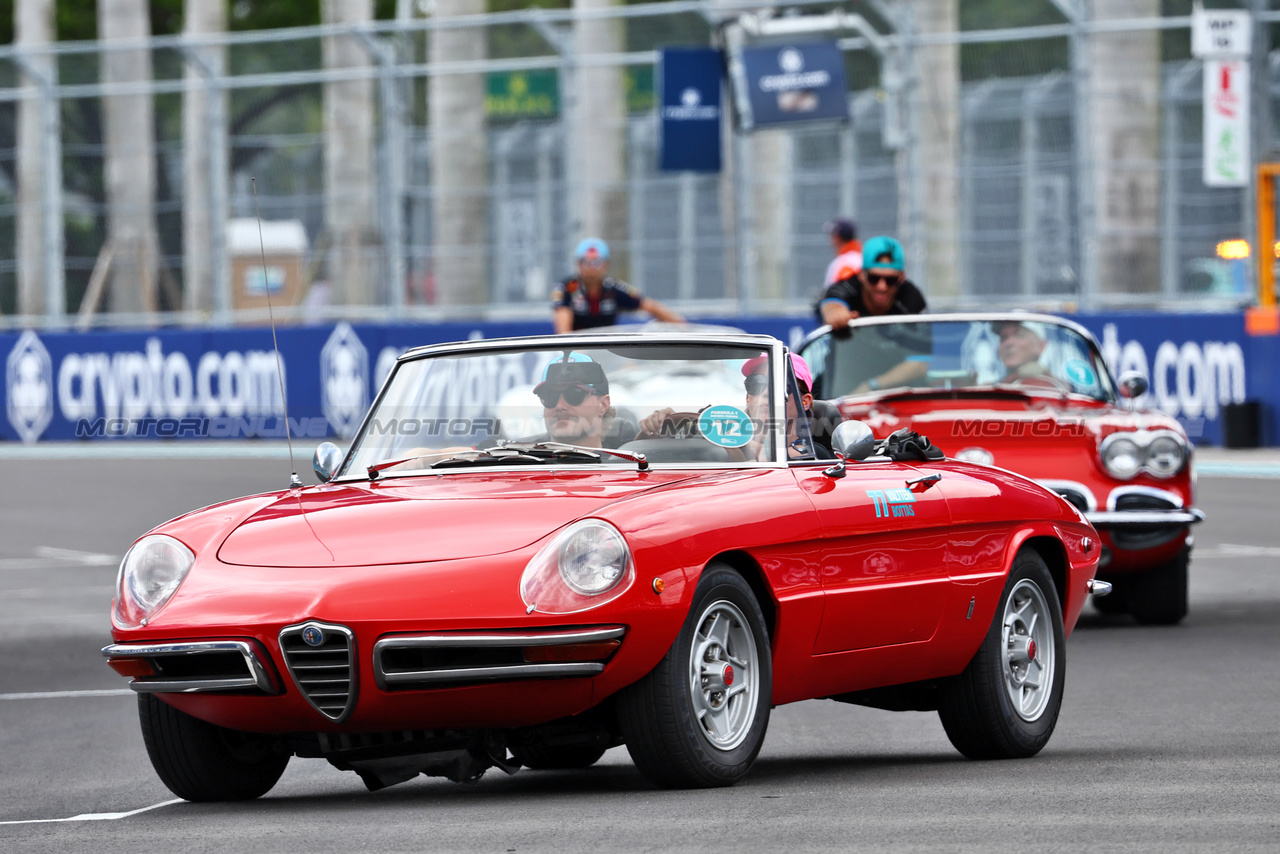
left=658, top=47, right=723, bottom=172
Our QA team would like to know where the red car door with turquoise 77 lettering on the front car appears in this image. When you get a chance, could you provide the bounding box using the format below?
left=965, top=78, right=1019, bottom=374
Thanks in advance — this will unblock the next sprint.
left=792, top=462, right=951, bottom=654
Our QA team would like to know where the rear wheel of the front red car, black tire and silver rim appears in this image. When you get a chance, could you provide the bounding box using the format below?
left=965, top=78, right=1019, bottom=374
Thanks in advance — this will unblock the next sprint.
left=938, top=549, right=1066, bottom=759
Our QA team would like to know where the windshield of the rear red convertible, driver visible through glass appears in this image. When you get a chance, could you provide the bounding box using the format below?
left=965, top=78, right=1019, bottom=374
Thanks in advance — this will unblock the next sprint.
left=803, top=318, right=1115, bottom=401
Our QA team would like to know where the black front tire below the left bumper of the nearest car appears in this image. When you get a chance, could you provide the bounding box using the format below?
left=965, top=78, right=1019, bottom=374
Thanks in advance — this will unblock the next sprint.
left=138, top=694, right=289, bottom=800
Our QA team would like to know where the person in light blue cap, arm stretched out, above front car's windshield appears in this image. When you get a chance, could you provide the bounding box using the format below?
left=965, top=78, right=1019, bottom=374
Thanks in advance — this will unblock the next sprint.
left=552, top=237, right=685, bottom=333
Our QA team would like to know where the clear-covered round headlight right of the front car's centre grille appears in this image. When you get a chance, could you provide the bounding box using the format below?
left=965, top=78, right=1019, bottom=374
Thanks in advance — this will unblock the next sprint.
left=520, top=519, right=635, bottom=613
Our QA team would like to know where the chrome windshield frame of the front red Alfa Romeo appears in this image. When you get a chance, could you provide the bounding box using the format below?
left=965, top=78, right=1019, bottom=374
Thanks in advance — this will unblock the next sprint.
left=329, top=328, right=787, bottom=483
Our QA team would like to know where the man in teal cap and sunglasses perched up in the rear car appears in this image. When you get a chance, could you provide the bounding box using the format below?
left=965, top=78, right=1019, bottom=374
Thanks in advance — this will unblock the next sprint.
left=815, top=237, right=927, bottom=329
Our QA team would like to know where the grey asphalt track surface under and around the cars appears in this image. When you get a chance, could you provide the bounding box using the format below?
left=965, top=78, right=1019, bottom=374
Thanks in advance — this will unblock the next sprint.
left=0, top=455, right=1280, bottom=854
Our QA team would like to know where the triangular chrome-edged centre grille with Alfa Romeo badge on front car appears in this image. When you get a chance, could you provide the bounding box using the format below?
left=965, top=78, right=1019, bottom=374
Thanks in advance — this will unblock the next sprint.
left=280, top=620, right=356, bottom=722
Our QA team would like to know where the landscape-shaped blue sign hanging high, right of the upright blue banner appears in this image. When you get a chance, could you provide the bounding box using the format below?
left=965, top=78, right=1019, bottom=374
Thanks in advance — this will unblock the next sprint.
left=733, top=41, right=849, bottom=129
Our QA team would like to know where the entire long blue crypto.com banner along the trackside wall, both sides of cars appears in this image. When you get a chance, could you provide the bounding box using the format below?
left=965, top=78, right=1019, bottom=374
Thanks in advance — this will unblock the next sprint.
left=0, top=312, right=1280, bottom=444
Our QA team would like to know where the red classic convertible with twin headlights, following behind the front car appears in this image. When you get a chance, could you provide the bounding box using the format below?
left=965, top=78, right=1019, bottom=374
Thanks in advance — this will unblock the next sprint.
left=801, top=312, right=1204, bottom=625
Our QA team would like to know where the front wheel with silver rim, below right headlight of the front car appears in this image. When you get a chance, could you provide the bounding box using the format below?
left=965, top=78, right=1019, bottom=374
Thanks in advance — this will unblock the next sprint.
left=618, top=563, right=773, bottom=789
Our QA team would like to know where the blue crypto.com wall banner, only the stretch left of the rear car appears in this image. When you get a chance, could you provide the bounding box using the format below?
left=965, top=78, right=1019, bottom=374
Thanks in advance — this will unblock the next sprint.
left=0, top=318, right=800, bottom=443
